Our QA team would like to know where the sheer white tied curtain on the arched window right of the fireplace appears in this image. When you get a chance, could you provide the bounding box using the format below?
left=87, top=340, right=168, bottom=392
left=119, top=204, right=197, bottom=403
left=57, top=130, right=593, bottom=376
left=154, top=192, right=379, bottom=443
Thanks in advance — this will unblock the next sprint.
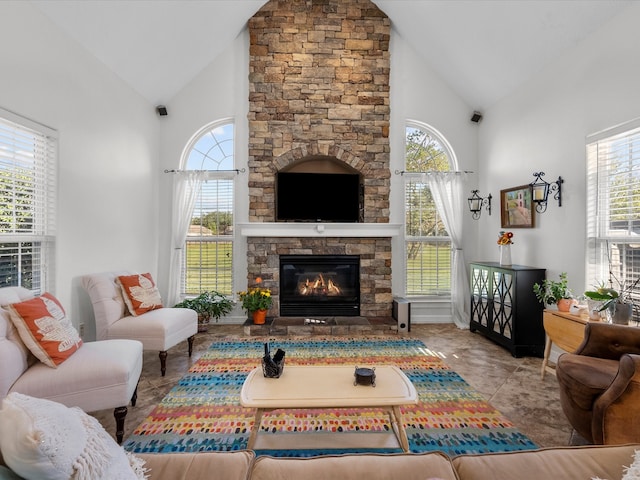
left=426, top=172, right=470, bottom=328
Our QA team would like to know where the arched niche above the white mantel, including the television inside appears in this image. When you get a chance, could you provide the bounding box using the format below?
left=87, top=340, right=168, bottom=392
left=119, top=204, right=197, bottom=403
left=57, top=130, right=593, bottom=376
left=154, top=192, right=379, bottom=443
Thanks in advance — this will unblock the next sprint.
left=275, top=155, right=364, bottom=223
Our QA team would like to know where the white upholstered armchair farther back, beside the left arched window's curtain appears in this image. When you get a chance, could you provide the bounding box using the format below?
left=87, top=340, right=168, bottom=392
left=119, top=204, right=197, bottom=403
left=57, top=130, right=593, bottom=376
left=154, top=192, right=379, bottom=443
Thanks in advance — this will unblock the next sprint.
left=82, top=272, right=198, bottom=376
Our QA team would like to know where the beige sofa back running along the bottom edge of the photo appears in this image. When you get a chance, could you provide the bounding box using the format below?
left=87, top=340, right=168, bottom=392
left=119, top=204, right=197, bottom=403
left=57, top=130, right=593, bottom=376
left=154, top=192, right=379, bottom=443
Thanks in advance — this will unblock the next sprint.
left=131, top=444, right=640, bottom=480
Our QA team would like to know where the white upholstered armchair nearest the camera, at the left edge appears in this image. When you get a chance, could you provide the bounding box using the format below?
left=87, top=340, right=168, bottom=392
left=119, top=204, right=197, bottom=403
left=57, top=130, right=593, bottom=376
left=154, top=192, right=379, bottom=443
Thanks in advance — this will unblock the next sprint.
left=0, top=287, right=142, bottom=443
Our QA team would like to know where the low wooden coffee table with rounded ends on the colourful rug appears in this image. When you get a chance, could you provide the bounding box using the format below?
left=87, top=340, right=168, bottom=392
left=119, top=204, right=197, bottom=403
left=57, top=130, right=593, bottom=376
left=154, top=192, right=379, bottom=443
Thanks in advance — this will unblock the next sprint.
left=240, top=365, right=418, bottom=452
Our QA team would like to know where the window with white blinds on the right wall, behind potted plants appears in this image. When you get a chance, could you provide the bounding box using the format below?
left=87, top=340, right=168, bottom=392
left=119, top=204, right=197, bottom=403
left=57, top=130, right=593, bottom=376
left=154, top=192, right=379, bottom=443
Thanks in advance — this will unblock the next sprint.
left=587, top=120, right=640, bottom=320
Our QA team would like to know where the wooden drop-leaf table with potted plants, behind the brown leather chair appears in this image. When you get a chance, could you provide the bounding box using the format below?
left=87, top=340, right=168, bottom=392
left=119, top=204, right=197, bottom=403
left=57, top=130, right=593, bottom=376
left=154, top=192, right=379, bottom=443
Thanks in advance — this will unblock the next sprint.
left=540, top=310, right=598, bottom=379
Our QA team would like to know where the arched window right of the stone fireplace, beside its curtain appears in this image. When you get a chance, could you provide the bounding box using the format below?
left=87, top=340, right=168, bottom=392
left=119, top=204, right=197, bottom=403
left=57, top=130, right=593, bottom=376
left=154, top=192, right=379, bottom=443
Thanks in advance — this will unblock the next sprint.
left=403, top=122, right=455, bottom=296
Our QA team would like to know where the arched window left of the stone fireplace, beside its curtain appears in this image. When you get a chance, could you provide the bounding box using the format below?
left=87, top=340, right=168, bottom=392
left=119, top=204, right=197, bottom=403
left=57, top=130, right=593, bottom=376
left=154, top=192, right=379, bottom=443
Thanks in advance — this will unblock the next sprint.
left=180, top=120, right=237, bottom=296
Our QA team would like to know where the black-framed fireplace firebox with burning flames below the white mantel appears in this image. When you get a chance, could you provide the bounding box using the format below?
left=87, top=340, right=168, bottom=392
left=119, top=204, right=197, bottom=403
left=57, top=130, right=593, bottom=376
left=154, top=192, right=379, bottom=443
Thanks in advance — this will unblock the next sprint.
left=280, top=255, right=360, bottom=317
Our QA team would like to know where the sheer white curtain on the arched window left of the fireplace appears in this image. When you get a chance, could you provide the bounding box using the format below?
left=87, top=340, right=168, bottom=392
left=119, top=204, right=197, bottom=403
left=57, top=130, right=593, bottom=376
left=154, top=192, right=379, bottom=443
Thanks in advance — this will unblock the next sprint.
left=167, top=170, right=207, bottom=306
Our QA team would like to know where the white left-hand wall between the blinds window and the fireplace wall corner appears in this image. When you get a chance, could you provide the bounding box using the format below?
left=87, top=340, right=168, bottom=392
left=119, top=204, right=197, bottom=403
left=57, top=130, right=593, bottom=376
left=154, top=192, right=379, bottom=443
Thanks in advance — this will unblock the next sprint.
left=0, top=2, right=158, bottom=337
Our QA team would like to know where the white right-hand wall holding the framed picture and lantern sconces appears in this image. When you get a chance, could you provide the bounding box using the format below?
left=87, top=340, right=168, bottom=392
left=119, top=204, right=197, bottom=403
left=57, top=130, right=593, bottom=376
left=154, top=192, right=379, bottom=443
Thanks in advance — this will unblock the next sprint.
left=479, top=4, right=640, bottom=294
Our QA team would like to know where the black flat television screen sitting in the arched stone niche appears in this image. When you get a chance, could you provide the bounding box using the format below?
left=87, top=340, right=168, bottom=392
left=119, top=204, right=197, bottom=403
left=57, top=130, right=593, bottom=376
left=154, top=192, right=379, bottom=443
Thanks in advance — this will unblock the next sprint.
left=276, top=172, right=360, bottom=223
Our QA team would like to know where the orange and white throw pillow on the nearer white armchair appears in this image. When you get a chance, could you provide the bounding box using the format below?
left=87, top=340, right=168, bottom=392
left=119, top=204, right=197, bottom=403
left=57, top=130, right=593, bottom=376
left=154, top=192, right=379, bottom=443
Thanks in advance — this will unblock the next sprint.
left=7, top=293, right=82, bottom=368
